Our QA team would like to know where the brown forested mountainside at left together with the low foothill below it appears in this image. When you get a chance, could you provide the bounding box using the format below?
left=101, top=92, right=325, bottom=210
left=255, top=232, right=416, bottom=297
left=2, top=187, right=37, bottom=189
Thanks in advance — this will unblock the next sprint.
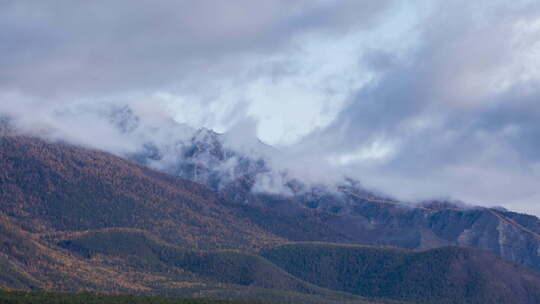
left=0, top=136, right=396, bottom=303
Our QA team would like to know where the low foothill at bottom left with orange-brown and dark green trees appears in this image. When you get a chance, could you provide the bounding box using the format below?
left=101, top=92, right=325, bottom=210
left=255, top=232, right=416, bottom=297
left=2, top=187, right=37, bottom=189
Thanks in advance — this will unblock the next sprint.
left=0, top=210, right=398, bottom=304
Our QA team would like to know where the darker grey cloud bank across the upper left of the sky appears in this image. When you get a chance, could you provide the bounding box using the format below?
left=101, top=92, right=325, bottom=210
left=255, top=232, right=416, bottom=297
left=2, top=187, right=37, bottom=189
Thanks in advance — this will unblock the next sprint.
left=0, top=0, right=388, bottom=98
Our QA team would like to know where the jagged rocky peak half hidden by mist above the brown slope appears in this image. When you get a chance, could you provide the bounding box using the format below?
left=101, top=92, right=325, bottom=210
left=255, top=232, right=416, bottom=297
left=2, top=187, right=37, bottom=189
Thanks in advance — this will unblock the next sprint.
left=104, top=107, right=271, bottom=191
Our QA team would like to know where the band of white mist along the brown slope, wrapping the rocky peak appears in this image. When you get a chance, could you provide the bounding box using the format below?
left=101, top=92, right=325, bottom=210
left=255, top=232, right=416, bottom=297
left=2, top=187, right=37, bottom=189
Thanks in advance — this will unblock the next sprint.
left=4, top=103, right=358, bottom=194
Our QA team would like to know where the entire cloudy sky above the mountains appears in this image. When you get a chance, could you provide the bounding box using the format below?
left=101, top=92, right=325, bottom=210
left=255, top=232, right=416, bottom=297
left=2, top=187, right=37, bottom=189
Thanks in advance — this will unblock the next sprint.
left=0, top=0, right=540, bottom=215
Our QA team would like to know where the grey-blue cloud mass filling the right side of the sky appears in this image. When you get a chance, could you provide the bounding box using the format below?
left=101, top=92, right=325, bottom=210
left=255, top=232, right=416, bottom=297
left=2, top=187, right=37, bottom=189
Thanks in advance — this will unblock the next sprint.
left=292, top=1, right=540, bottom=214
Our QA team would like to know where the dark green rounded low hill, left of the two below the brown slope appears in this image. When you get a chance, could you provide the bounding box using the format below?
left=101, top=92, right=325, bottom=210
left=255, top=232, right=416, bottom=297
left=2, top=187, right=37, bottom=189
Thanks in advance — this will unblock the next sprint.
left=51, top=229, right=388, bottom=301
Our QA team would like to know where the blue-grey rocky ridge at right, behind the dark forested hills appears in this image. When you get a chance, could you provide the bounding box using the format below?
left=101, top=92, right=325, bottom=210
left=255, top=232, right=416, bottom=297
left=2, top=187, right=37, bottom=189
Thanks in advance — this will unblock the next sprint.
left=217, top=176, right=540, bottom=272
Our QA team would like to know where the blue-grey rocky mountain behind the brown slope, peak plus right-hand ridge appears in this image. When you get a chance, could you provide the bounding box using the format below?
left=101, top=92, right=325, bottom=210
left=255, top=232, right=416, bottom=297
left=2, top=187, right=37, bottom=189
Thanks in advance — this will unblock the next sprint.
left=125, top=129, right=540, bottom=272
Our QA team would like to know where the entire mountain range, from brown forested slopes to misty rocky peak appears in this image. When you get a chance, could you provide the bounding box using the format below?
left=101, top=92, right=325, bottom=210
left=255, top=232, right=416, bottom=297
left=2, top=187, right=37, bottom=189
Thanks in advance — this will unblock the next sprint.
left=0, top=122, right=540, bottom=303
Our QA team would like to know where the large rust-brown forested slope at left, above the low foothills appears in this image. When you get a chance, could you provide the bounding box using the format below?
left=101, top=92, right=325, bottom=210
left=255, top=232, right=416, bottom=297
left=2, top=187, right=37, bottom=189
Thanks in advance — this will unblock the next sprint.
left=0, top=137, right=282, bottom=249
